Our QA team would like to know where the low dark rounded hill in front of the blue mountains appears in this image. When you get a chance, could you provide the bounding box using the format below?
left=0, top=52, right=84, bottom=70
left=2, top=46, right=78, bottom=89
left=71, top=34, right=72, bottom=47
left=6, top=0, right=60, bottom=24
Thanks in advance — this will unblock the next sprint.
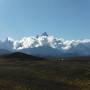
left=0, top=52, right=45, bottom=63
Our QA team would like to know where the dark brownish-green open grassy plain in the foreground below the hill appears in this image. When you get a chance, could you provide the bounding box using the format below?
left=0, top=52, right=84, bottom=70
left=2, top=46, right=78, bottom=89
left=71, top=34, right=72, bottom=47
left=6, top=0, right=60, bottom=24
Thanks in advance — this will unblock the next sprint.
left=0, top=52, right=90, bottom=90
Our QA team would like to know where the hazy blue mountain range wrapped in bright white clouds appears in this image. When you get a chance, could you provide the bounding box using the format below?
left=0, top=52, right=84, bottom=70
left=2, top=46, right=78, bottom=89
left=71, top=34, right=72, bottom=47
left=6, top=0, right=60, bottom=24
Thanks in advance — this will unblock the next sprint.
left=0, top=32, right=90, bottom=57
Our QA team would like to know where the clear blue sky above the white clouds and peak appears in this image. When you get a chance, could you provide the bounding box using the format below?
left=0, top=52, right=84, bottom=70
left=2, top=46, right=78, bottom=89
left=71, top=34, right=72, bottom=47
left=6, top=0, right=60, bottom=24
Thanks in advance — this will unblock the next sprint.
left=0, top=0, right=90, bottom=40
